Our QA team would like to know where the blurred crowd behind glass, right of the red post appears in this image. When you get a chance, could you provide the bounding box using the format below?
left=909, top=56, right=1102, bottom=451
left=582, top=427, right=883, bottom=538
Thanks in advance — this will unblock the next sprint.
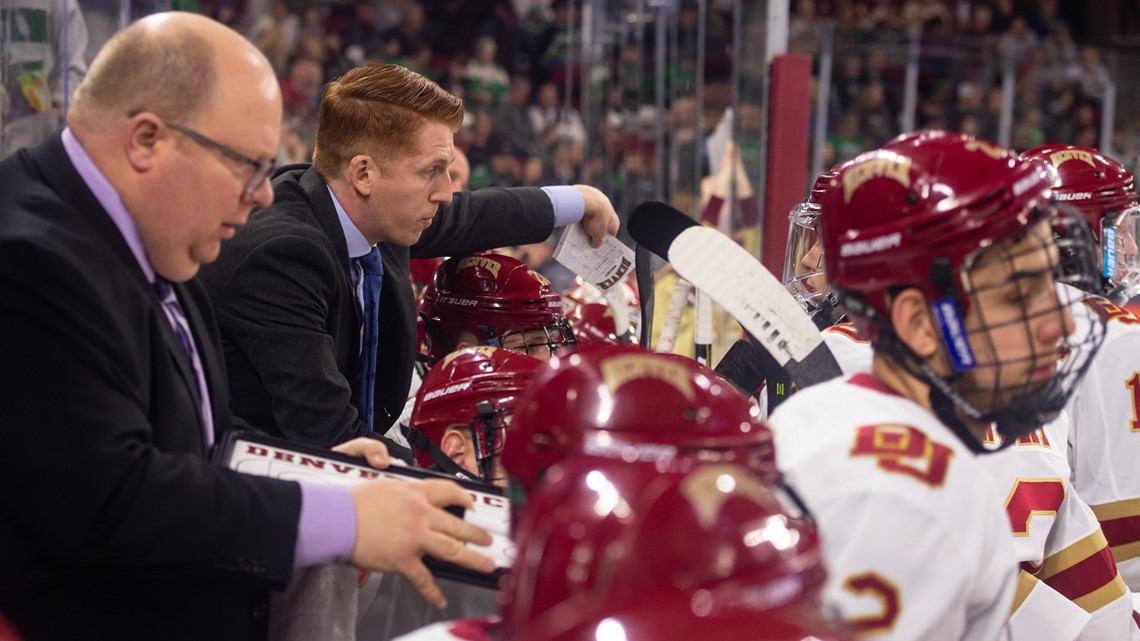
left=790, top=0, right=1138, bottom=167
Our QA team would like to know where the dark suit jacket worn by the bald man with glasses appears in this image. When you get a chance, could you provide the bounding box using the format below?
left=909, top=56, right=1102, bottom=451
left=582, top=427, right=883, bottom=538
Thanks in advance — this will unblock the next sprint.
left=0, top=136, right=300, bottom=641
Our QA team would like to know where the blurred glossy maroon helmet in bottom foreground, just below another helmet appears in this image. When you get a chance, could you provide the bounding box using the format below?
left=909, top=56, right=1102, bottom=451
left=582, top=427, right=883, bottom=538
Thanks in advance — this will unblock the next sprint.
left=500, top=454, right=825, bottom=640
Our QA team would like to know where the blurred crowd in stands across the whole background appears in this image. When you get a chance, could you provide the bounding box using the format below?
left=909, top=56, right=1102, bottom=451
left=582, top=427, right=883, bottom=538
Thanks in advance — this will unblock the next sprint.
left=202, top=0, right=1140, bottom=211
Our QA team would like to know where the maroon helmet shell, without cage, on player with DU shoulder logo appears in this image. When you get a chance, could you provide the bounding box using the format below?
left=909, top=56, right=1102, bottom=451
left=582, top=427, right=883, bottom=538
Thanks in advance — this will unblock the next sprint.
left=820, top=132, right=1056, bottom=326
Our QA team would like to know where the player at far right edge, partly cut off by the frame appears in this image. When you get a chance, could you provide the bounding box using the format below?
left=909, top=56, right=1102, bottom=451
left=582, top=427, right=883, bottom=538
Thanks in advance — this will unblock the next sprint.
left=1024, top=145, right=1140, bottom=591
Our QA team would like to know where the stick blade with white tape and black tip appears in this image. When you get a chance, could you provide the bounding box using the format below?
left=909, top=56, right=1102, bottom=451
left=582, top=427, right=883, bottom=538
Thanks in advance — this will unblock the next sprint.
left=629, top=202, right=841, bottom=388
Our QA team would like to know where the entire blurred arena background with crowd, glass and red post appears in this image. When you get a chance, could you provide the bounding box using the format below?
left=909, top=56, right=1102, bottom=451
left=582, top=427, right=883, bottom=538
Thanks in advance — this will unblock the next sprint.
left=0, top=0, right=1140, bottom=354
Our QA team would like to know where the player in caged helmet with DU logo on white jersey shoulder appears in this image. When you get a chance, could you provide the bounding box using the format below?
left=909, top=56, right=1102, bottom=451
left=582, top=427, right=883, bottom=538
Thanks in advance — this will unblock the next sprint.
left=774, top=133, right=1099, bottom=639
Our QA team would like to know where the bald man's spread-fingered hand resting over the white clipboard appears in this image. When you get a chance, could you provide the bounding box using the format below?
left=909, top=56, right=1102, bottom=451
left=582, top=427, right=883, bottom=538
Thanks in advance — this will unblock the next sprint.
left=345, top=476, right=495, bottom=608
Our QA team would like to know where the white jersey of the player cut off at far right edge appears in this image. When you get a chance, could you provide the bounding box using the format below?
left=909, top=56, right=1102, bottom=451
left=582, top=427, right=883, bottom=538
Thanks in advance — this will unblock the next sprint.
left=1068, top=297, right=1140, bottom=591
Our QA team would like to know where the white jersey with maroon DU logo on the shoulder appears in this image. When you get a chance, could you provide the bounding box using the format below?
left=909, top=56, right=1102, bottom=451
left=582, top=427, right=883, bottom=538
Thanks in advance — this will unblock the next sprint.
left=772, top=374, right=1018, bottom=641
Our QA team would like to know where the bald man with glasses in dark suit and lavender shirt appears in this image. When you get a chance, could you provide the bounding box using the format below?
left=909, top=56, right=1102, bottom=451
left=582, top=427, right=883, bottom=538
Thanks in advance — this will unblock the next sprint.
left=0, top=13, right=492, bottom=641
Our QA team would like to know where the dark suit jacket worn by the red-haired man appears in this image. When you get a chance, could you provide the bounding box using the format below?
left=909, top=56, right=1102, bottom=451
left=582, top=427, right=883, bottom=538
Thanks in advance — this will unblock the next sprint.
left=202, top=165, right=554, bottom=446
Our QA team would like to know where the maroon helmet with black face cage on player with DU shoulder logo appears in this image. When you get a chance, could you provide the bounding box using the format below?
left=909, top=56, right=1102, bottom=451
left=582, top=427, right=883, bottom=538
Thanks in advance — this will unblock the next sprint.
left=820, top=131, right=1104, bottom=449
